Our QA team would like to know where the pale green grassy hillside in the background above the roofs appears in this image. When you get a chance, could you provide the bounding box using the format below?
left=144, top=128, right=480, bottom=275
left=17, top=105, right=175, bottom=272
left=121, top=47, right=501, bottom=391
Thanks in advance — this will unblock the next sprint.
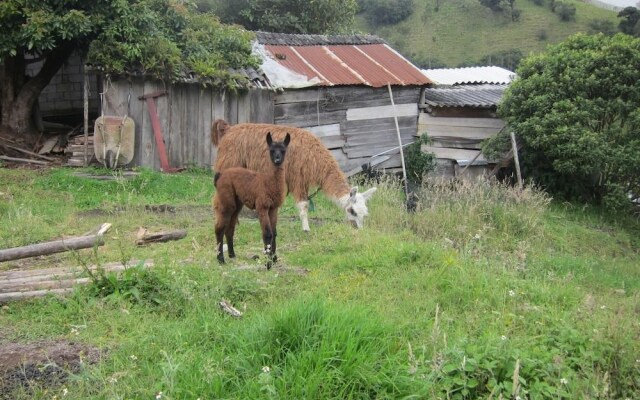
left=357, top=0, right=619, bottom=67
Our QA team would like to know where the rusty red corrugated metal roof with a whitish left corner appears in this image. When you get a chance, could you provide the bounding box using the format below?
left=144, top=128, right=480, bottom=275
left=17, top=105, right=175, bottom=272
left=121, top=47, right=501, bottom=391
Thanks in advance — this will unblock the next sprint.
left=254, top=32, right=431, bottom=88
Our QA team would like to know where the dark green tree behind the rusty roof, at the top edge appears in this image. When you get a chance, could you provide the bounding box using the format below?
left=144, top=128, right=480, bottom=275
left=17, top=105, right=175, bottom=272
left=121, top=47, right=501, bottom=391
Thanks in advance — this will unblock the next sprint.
left=228, top=0, right=358, bottom=34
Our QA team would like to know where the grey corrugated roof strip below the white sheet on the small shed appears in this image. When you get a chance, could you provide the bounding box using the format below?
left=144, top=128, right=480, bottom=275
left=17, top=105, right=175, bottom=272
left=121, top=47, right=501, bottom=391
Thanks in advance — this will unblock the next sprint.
left=420, top=85, right=508, bottom=108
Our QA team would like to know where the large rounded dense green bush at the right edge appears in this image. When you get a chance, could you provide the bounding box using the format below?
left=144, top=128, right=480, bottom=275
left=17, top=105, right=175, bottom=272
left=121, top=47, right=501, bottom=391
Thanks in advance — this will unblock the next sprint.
left=498, top=34, right=640, bottom=211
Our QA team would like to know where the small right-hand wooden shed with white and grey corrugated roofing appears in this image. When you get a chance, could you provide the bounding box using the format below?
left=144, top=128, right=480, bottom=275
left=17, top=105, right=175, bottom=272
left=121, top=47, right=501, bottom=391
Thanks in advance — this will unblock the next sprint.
left=418, top=66, right=515, bottom=178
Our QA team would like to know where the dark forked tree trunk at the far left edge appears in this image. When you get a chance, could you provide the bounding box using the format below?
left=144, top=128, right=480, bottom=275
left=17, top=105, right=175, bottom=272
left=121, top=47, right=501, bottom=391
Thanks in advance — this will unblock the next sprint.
left=0, top=44, right=74, bottom=140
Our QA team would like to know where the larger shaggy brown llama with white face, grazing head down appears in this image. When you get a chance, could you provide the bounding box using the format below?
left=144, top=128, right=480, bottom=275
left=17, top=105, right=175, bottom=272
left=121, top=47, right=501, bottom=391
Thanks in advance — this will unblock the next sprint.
left=211, top=119, right=376, bottom=231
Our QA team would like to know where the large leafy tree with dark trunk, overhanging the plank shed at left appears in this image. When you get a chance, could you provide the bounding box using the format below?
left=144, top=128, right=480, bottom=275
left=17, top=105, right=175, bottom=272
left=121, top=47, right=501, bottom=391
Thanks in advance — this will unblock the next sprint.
left=0, top=0, right=257, bottom=141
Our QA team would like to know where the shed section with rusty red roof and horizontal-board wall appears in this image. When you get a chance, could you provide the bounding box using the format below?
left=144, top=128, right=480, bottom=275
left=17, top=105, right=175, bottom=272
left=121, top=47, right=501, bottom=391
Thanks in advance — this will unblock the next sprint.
left=255, top=32, right=430, bottom=171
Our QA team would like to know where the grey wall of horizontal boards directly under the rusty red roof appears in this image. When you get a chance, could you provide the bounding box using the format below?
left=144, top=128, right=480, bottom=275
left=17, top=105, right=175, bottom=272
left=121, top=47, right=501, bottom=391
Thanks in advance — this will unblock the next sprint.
left=274, top=86, right=420, bottom=171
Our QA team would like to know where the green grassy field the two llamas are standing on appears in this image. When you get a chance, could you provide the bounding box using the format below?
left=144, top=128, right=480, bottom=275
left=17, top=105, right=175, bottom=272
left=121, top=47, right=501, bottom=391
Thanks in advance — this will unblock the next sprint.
left=0, top=169, right=640, bottom=399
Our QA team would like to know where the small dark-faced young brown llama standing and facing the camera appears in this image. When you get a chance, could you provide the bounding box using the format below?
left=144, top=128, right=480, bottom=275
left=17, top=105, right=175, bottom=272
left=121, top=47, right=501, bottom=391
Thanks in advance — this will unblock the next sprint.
left=213, top=132, right=291, bottom=269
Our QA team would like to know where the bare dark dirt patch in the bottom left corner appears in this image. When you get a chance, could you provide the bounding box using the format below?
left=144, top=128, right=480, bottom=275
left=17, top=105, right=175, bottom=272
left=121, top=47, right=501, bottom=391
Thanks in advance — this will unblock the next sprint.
left=0, top=329, right=101, bottom=400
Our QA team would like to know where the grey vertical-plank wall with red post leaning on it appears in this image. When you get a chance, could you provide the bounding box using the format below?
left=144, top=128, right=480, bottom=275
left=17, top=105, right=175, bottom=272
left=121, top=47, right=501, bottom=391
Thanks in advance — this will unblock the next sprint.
left=104, top=78, right=273, bottom=170
